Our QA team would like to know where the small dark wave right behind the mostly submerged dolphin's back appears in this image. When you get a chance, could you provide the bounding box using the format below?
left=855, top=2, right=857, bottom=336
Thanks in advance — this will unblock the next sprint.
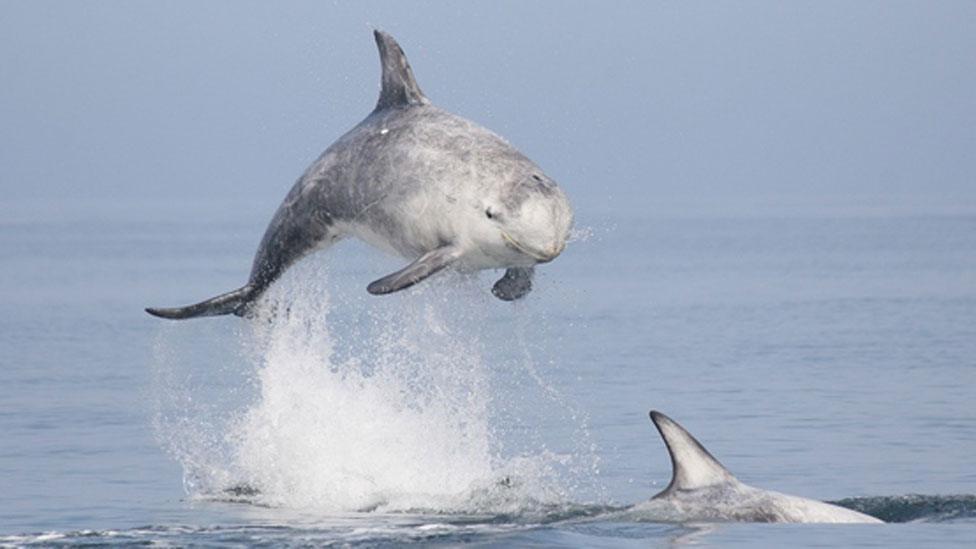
left=828, top=494, right=976, bottom=522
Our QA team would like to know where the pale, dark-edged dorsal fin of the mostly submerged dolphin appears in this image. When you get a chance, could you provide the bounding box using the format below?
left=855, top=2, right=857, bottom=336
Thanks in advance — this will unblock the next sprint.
left=651, top=410, right=738, bottom=497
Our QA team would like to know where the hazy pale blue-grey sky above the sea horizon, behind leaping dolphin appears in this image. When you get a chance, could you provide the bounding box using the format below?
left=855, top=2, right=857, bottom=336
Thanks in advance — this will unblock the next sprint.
left=0, top=0, right=976, bottom=217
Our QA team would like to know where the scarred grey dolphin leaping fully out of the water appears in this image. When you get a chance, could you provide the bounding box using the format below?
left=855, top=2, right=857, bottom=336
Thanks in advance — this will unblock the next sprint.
left=146, top=30, right=573, bottom=319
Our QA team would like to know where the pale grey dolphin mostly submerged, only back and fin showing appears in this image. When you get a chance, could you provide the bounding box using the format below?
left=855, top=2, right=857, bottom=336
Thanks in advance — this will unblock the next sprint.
left=628, top=411, right=882, bottom=523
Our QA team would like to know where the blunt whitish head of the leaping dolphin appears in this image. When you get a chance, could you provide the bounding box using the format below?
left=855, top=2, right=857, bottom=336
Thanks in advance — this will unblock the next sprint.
left=477, top=168, right=573, bottom=266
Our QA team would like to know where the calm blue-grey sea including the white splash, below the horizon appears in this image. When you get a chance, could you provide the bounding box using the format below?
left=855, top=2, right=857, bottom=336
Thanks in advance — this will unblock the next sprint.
left=0, top=201, right=976, bottom=547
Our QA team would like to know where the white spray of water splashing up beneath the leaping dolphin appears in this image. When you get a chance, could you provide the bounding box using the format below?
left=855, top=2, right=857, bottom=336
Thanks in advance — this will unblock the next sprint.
left=153, top=265, right=595, bottom=513
